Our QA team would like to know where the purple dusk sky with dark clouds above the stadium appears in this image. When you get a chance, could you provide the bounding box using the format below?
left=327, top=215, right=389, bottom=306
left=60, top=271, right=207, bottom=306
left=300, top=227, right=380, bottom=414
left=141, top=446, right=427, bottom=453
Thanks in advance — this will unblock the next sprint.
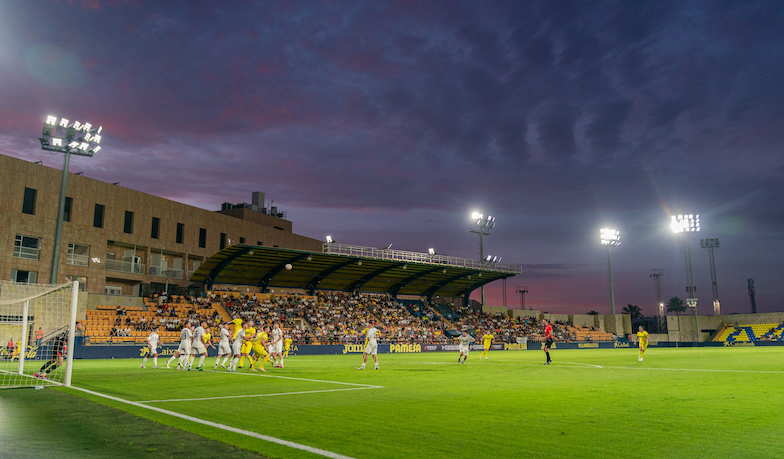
left=0, top=0, right=784, bottom=315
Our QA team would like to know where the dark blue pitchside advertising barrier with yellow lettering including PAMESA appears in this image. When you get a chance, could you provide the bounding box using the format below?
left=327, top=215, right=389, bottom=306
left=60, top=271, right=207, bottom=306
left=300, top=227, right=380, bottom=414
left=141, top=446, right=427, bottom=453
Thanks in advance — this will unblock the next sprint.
left=59, top=340, right=784, bottom=359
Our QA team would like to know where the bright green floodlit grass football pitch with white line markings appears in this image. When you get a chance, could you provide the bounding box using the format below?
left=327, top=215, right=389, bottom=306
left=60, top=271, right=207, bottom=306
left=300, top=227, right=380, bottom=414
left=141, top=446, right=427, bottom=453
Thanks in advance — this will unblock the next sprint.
left=0, top=347, right=784, bottom=458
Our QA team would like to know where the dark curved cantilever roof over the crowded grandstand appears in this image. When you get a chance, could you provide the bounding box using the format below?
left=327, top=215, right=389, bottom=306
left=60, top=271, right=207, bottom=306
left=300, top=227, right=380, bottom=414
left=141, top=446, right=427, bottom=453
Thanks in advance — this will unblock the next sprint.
left=190, top=244, right=520, bottom=297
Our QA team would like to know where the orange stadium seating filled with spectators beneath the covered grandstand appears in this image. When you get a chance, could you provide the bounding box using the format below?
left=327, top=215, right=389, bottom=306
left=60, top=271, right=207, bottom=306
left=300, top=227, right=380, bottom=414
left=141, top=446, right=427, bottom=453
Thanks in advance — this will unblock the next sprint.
left=85, top=291, right=620, bottom=344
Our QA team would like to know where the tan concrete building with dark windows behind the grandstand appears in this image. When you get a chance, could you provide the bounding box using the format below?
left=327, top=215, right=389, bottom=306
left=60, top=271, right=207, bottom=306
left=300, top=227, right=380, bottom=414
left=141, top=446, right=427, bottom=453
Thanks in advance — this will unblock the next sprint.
left=0, top=155, right=322, bottom=296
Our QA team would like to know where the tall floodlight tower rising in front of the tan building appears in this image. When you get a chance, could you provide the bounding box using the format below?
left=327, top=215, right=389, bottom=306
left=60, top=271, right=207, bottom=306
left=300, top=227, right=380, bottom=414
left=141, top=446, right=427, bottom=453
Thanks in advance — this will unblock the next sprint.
left=38, top=116, right=103, bottom=284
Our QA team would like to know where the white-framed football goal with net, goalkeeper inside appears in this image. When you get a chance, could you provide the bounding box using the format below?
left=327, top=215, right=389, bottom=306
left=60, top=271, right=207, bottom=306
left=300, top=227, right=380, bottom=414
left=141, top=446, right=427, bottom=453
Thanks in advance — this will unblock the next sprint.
left=0, top=281, right=79, bottom=389
